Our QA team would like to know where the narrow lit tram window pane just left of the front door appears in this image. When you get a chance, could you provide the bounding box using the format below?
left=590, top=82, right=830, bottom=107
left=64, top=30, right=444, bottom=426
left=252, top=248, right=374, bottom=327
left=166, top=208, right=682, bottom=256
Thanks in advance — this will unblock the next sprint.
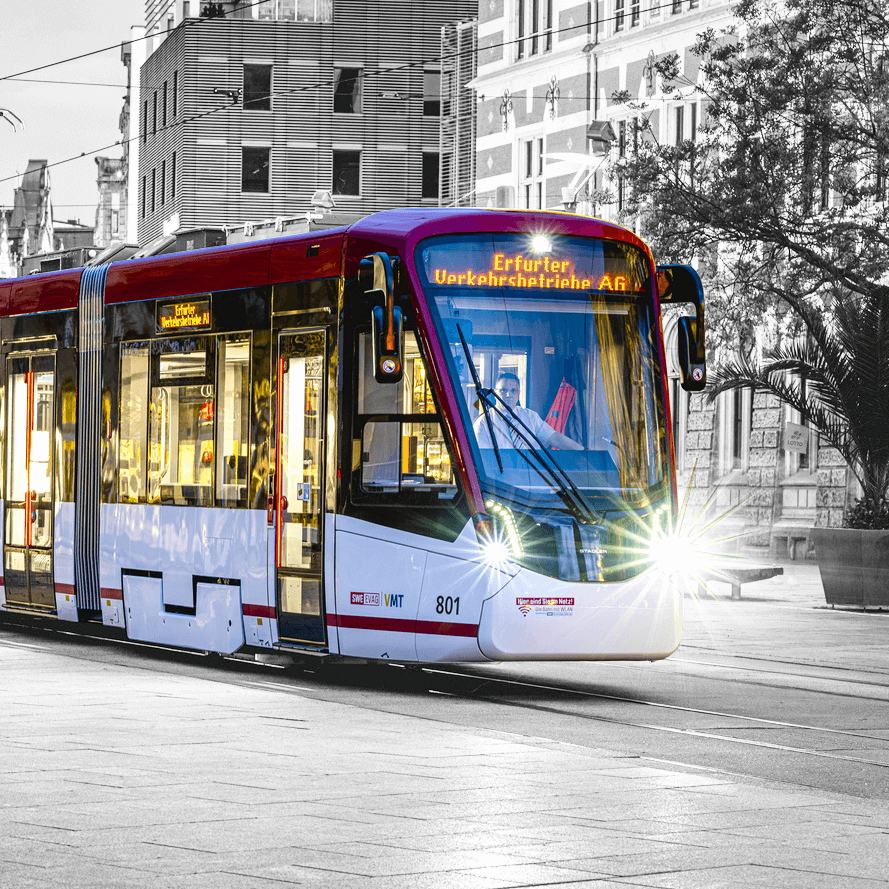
left=216, top=337, right=250, bottom=506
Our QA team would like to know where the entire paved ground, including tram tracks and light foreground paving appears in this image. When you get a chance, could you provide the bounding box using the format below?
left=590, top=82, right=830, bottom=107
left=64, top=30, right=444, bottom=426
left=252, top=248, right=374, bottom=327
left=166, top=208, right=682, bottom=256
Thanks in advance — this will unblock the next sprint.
left=0, top=566, right=889, bottom=889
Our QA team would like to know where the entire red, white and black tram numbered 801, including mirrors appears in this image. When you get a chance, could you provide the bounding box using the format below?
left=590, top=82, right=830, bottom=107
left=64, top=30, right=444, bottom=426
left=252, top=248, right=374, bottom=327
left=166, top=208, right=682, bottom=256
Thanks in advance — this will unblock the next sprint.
left=0, top=209, right=705, bottom=663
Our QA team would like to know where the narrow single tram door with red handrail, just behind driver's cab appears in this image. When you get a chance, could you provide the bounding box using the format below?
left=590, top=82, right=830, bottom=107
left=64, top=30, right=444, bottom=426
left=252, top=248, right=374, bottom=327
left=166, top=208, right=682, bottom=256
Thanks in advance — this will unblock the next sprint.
left=272, top=329, right=327, bottom=645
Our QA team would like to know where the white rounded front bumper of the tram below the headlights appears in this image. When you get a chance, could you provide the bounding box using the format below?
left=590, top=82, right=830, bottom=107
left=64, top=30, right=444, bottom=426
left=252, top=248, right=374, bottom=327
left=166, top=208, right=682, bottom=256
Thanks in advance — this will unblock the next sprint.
left=478, top=569, right=682, bottom=661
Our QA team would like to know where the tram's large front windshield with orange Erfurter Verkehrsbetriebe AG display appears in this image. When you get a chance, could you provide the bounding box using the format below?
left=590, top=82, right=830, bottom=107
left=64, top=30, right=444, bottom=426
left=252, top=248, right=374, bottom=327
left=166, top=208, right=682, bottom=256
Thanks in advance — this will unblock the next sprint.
left=417, top=234, right=668, bottom=508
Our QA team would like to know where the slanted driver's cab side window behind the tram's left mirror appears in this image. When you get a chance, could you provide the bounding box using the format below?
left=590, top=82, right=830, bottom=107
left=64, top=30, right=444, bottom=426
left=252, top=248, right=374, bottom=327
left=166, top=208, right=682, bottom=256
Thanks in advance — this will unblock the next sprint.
left=353, top=331, right=457, bottom=500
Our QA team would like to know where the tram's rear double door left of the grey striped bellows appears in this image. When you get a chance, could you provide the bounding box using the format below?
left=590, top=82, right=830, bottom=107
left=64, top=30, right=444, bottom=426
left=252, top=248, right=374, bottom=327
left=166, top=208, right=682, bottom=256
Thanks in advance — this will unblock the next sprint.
left=3, top=354, right=55, bottom=609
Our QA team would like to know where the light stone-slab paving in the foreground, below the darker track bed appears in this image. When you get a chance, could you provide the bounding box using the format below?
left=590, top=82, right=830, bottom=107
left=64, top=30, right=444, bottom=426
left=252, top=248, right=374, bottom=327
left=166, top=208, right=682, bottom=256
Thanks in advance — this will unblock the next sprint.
left=0, top=630, right=889, bottom=889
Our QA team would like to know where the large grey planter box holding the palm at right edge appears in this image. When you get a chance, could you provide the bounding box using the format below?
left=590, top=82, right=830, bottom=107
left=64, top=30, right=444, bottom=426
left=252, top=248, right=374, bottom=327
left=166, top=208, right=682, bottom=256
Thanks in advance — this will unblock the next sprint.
left=812, top=528, right=889, bottom=608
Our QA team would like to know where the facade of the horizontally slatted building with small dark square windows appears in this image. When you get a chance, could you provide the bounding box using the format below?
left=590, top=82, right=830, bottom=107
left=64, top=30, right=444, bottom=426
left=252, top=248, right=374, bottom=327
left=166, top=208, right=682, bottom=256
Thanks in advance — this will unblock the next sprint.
left=131, top=0, right=476, bottom=244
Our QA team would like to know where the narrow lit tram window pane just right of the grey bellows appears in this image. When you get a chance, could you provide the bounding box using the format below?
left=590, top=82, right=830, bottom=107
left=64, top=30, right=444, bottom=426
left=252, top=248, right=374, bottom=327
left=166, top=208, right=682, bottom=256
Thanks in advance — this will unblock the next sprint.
left=118, top=344, right=148, bottom=503
